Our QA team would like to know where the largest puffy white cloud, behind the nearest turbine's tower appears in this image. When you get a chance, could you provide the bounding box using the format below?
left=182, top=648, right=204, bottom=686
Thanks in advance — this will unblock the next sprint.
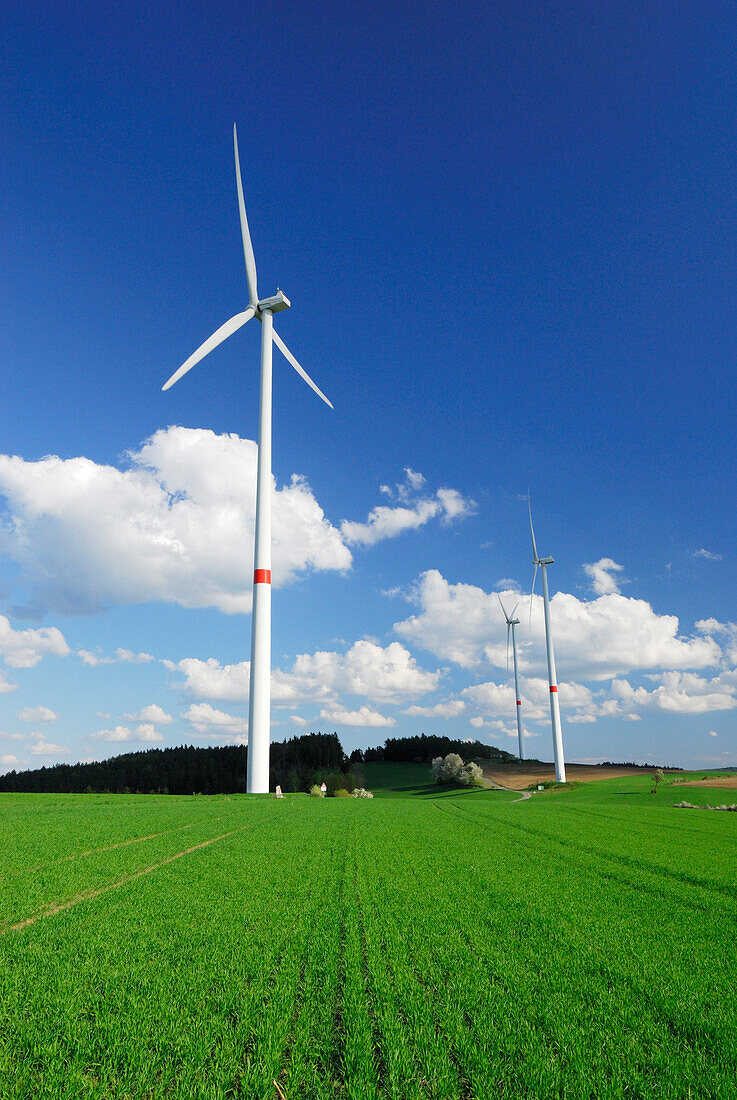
left=0, top=427, right=351, bottom=616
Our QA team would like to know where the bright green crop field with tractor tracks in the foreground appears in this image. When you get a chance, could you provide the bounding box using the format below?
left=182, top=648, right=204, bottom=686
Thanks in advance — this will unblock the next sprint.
left=0, top=766, right=737, bottom=1100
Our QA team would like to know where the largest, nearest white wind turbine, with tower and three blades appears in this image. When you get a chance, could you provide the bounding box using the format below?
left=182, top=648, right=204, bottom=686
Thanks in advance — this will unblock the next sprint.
left=162, top=127, right=332, bottom=794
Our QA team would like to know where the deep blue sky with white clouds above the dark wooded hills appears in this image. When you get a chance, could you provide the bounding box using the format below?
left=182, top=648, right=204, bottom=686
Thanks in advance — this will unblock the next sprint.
left=0, top=2, right=737, bottom=770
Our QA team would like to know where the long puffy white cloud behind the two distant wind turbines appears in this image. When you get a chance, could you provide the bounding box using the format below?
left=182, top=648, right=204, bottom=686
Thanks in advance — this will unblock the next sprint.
left=394, top=570, right=722, bottom=680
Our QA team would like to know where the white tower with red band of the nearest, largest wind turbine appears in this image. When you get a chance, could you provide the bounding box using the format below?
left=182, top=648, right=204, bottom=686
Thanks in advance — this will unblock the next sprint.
left=245, top=309, right=273, bottom=794
